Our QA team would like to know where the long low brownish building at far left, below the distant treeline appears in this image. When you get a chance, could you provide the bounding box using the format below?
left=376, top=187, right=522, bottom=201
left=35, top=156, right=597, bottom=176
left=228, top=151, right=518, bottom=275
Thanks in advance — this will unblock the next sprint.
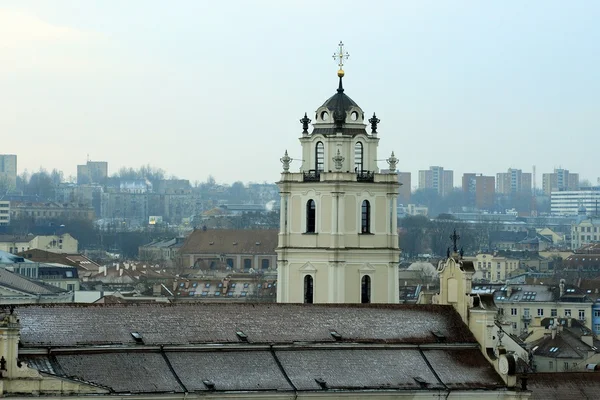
left=10, top=201, right=95, bottom=221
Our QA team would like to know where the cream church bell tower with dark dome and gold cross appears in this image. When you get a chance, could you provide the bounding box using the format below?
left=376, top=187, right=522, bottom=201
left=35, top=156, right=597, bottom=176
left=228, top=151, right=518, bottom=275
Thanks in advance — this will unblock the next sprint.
left=277, top=42, right=400, bottom=303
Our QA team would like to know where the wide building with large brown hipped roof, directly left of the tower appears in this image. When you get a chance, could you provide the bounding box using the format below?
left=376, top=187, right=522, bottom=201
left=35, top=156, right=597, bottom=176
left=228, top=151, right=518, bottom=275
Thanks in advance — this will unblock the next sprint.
left=179, top=229, right=277, bottom=272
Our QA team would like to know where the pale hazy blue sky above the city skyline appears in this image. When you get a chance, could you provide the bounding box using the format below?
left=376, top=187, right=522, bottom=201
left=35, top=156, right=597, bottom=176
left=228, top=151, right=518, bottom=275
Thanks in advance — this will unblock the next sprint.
left=0, top=0, right=600, bottom=186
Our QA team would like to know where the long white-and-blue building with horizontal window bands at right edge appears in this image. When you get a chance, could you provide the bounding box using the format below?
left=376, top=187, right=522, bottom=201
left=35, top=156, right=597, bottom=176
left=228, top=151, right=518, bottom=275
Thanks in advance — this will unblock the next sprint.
left=550, top=186, right=600, bottom=215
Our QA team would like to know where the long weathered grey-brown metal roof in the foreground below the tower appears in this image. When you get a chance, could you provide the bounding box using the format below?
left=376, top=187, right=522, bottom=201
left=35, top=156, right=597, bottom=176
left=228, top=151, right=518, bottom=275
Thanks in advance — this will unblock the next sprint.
left=0, top=303, right=531, bottom=400
